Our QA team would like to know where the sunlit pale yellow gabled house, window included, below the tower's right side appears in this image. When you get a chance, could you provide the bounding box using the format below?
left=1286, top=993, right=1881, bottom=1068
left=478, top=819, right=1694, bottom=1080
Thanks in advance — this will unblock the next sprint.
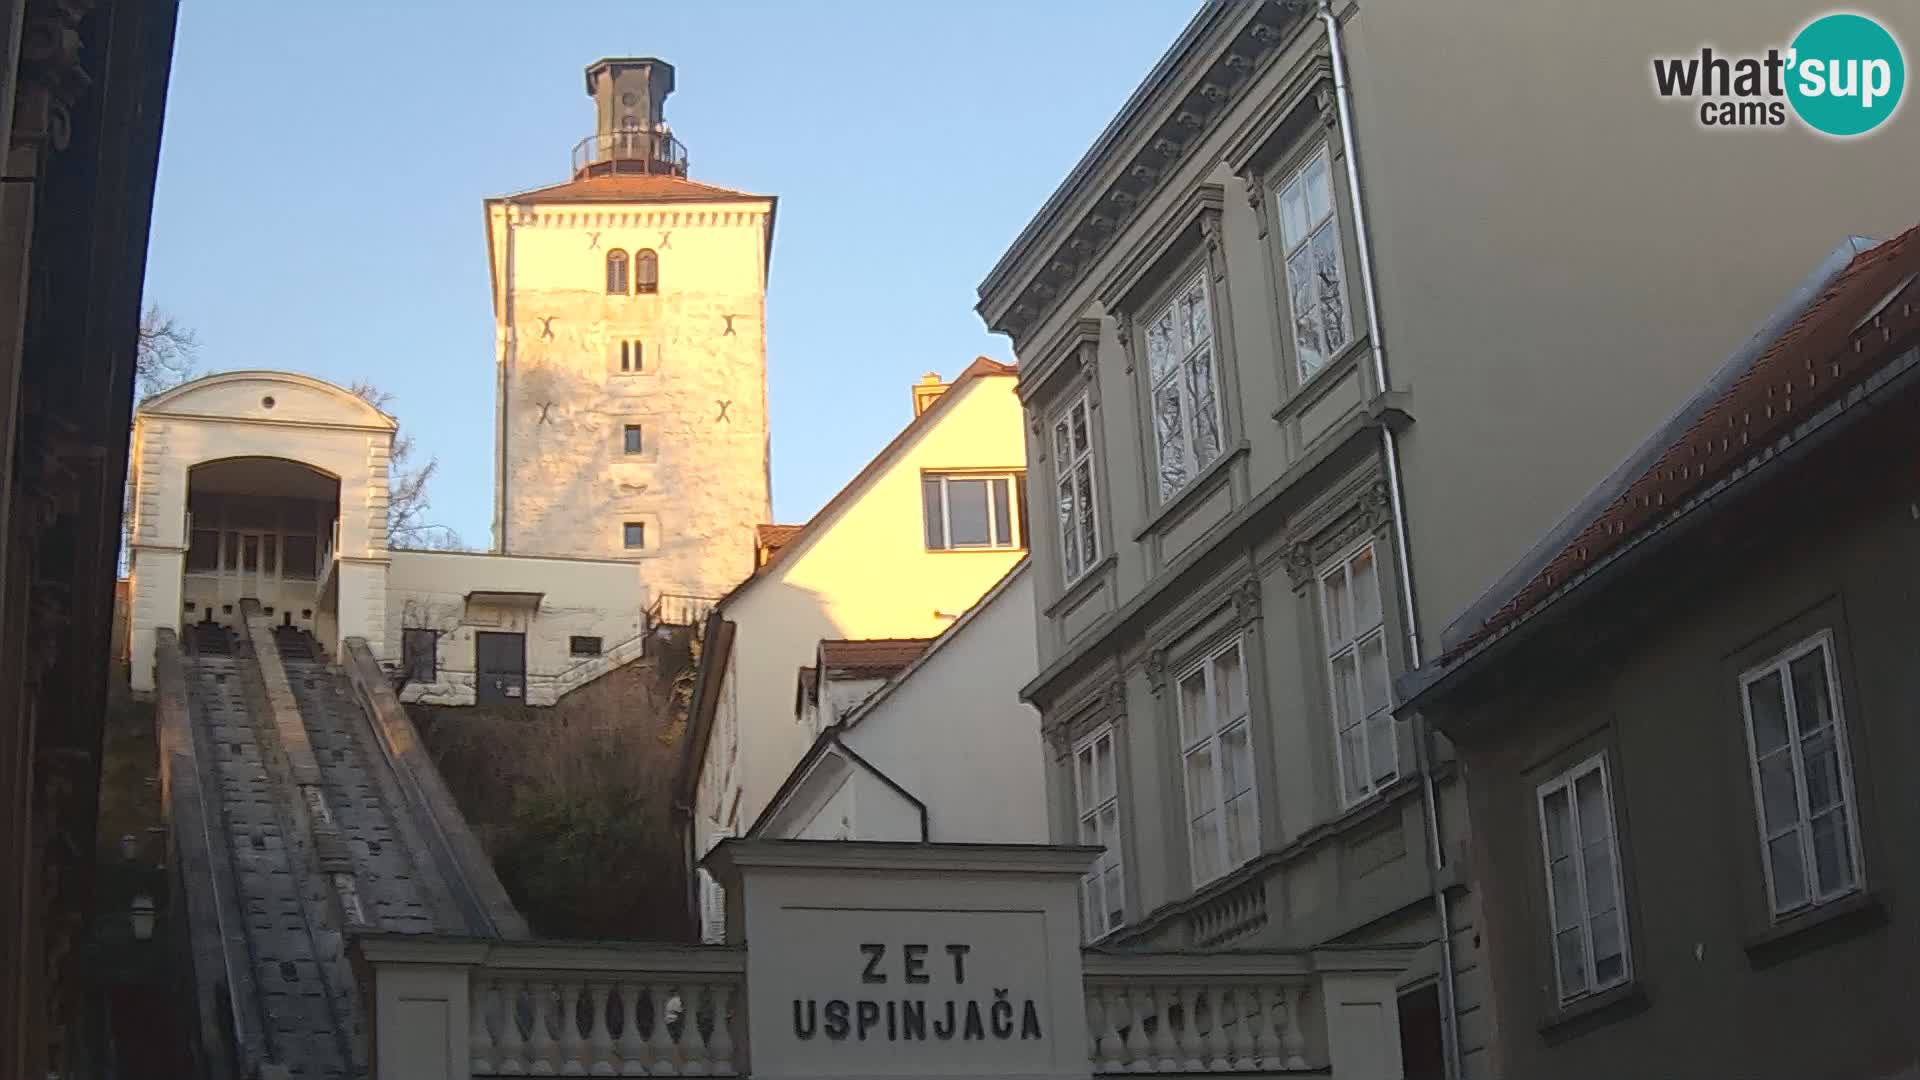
left=680, top=359, right=1027, bottom=922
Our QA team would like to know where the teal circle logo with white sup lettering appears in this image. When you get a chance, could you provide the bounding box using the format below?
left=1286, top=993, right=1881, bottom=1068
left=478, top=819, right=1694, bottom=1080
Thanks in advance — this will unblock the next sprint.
left=1788, top=13, right=1907, bottom=136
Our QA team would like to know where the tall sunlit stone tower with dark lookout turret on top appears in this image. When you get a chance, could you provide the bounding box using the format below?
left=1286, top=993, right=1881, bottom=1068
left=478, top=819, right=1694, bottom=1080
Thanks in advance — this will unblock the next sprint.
left=486, top=60, right=774, bottom=605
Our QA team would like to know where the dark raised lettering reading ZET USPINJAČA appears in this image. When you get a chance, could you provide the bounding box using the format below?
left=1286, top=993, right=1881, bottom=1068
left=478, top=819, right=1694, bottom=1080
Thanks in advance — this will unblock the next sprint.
left=793, top=942, right=1044, bottom=1042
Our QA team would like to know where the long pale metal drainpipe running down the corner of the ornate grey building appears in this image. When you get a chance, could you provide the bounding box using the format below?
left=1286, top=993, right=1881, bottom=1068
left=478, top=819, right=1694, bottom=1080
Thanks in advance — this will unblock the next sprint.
left=1319, top=0, right=1461, bottom=1080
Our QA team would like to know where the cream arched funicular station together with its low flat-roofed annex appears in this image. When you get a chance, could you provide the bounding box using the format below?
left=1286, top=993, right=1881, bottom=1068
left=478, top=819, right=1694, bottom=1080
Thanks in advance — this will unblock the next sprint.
left=129, top=371, right=649, bottom=705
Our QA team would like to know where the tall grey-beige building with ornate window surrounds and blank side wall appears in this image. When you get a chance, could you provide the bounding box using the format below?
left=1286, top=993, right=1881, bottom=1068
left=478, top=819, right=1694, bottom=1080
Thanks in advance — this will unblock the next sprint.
left=979, top=0, right=1920, bottom=1078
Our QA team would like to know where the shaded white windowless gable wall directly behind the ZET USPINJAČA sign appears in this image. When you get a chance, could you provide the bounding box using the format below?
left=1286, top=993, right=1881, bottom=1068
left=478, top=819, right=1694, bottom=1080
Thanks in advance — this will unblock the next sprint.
left=841, top=567, right=1048, bottom=844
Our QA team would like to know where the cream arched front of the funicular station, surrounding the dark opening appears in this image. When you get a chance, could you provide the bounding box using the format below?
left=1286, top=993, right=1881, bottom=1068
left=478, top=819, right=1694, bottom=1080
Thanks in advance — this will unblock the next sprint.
left=132, top=371, right=394, bottom=690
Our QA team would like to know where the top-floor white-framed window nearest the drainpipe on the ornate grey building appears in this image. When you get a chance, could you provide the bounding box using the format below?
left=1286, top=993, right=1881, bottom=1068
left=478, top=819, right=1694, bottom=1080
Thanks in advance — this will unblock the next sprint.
left=1275, top=146, right=1352, bottom=382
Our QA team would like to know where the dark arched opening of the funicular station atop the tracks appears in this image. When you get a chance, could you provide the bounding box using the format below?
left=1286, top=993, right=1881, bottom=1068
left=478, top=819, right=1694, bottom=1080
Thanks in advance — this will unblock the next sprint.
left=182, top=457, right=340, bottom=630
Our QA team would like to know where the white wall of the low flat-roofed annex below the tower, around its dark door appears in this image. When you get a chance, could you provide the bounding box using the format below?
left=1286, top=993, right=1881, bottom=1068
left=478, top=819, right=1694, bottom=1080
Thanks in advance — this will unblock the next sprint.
left=385, top=552, right=647, bottom=705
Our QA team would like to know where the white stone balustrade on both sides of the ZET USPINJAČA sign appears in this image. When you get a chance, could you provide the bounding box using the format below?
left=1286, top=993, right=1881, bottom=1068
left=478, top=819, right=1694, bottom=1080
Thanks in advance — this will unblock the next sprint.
left=361, top=936, right=1409, bottom=1080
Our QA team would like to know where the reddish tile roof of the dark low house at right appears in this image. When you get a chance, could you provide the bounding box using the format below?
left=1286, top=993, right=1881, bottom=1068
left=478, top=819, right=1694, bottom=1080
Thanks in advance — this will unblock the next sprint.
left=1440, top=225, right=1920, bottom=663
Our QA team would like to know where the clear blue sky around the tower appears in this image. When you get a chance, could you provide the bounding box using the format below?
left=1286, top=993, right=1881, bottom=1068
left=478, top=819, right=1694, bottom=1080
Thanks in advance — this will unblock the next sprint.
left=146, top=0, right=1198, bottom=548
